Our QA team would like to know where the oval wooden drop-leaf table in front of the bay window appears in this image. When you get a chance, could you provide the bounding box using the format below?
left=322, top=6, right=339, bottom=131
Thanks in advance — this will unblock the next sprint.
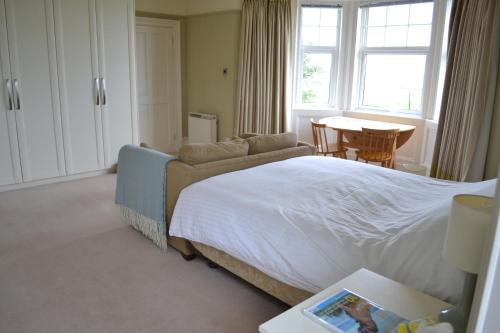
left=318, top=116, right=416, bottom=149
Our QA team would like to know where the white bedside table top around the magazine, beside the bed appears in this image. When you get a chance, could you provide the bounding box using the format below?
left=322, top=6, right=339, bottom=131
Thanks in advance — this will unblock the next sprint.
left=259, top=269, right=450, bottom=333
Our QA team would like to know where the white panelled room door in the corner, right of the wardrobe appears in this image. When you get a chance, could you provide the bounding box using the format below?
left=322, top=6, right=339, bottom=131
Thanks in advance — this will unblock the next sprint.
left=136, top=18, right=182, bottom=152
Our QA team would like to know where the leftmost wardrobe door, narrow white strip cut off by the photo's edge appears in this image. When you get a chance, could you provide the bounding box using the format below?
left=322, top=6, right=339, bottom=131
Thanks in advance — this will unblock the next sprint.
left=0, top=0, right=22, bottom=185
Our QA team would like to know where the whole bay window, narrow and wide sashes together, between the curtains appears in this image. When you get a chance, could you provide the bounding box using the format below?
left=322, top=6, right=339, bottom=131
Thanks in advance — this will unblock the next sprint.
left=293, top=0, right=451, bottom=119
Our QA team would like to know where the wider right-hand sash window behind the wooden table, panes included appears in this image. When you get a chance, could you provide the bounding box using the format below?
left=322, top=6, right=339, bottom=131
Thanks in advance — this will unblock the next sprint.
left=357, top=1, right=434, bottom=114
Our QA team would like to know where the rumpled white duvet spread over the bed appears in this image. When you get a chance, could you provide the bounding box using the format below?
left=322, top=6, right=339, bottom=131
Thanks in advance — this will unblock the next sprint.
left=170, top=156, right=496, bottom=301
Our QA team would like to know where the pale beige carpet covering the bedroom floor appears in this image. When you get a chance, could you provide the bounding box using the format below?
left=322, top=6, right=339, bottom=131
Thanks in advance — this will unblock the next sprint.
left=0, top=175, right=286, bottom=333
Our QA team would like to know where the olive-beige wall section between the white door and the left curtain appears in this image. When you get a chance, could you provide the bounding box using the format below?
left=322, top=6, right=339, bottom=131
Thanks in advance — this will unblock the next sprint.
left=183, top=10, right=241, bottom=140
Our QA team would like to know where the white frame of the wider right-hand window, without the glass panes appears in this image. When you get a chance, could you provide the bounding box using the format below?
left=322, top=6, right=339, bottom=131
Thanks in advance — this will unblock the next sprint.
left=353, top=0, right=439, bottom=118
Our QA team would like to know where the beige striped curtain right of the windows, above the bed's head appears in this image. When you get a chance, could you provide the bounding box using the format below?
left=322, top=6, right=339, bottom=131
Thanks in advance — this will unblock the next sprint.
left=431, top=0, right=499, bottom=181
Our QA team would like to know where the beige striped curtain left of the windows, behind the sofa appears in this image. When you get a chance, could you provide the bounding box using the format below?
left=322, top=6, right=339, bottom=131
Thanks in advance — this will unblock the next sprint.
left=234, top=0, right=291, bottom=134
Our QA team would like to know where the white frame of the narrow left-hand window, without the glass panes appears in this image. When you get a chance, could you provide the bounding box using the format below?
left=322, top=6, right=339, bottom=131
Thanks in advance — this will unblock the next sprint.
left=293, top=1, right=343, bottom=109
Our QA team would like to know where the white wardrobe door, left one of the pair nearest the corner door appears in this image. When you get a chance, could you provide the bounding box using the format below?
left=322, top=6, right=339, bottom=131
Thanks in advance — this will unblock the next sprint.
left=54, top=0, right=104, bottom=174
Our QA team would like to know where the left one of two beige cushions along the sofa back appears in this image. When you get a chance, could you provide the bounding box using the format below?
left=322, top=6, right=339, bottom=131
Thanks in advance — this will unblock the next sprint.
left=178, top=139, right=248, bottom=165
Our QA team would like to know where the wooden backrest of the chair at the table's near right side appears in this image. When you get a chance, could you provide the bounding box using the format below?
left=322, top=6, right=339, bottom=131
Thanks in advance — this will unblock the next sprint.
left=360, top=128, right=399, bottom=158
